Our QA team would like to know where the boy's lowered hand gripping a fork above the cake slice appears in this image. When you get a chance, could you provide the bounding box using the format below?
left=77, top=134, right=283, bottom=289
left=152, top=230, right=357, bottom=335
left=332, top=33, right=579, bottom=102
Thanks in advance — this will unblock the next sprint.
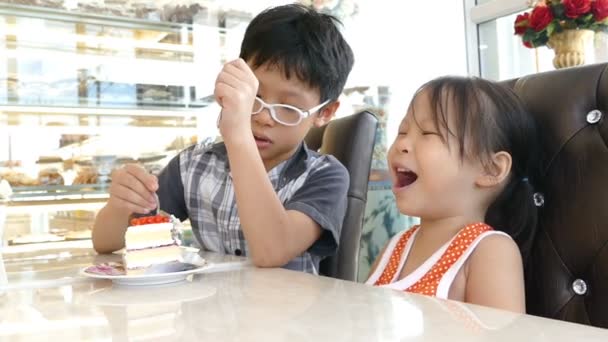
left=108, top=164, right=158, bottom=215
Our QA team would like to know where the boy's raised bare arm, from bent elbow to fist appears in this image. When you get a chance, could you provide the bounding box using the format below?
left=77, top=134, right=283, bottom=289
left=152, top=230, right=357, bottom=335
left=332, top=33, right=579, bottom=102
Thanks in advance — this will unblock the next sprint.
left=215, top=59, right=346, bottom=267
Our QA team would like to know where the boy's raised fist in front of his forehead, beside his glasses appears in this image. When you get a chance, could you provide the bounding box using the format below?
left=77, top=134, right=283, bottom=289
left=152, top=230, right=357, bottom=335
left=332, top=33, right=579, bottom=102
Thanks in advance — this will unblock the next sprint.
left=214, top=58, right=258, bottom=140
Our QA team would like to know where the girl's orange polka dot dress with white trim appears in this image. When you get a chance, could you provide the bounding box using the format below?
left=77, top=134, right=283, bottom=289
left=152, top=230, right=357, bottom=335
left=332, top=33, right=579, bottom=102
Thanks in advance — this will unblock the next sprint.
left=366, top=223, right=508, bottom=299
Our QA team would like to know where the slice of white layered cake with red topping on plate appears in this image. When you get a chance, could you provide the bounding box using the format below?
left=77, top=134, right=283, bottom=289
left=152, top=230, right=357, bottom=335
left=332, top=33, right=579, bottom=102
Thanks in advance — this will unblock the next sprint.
left=123, top=215, right=182, bottom=275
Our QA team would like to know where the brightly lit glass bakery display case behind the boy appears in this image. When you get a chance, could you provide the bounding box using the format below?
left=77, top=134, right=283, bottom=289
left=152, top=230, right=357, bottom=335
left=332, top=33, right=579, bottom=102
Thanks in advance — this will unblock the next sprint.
left=0, top=1, right=250, bottom=245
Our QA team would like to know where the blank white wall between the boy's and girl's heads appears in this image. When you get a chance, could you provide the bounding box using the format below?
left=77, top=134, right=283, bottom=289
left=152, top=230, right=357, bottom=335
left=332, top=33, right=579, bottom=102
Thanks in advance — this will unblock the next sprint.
left=344, top=0, right=467, bottom=144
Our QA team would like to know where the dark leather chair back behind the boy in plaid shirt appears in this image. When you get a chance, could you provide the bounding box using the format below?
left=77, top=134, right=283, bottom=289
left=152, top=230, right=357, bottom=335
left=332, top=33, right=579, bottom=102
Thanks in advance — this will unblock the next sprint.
left=305, top=111, right=378, bottom=281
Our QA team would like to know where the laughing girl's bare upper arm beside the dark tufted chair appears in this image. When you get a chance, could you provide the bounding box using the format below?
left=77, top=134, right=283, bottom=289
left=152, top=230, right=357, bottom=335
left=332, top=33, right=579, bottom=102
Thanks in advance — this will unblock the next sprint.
left=465, top=235, right=526, bottom=313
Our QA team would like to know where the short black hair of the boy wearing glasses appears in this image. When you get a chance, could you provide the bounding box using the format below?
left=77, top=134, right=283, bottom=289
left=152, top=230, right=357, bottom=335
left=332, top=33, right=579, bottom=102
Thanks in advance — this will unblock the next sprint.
left=240, top=4, right=354, bottom=102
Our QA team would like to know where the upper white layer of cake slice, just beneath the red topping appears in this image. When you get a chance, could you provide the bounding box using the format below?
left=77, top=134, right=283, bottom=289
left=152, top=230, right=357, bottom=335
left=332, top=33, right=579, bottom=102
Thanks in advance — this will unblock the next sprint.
left=125, top=222, right=175, bottom=250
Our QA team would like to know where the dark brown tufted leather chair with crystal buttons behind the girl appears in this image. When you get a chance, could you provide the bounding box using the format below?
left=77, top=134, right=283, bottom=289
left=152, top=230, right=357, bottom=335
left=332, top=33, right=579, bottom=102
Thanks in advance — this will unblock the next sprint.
left=504, top=64, right=608, bottom=328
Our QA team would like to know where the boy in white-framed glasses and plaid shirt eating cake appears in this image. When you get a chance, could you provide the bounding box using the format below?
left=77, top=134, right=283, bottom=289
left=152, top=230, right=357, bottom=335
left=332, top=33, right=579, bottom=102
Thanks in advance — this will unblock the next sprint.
left=93, top=4, right=354, bottom=274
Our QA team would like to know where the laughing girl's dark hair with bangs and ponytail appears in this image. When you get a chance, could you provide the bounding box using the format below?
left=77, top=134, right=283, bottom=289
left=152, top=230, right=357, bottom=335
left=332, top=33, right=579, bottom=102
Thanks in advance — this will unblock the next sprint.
left=414, top=77, right=541, bottom=260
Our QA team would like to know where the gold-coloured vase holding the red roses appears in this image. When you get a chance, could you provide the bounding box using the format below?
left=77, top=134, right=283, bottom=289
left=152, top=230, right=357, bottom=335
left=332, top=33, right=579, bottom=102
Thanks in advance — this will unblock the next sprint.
left=547, top=30, right=594, bottom=69
